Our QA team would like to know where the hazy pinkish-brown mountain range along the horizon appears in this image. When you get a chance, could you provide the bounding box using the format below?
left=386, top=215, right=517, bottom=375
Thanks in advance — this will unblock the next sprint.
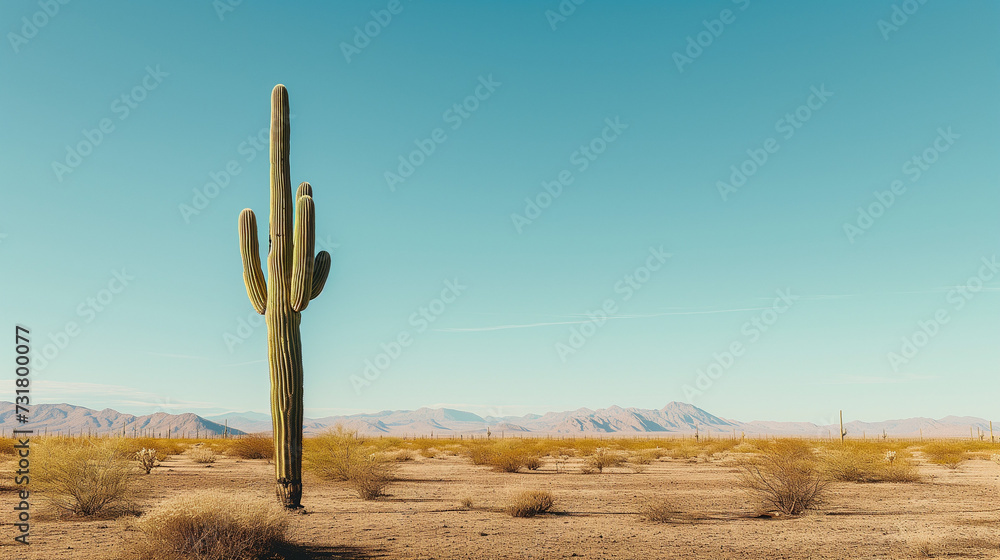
left=0, top=401, right=1000, bottom=437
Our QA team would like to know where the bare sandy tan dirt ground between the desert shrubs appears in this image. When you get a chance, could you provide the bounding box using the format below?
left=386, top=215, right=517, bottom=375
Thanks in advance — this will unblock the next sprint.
left=0, top=450, right=1000, bottom=560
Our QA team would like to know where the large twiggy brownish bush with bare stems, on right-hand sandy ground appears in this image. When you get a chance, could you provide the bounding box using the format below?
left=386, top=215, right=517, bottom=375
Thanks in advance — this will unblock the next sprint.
left=738, top=440, right=828, bottom=515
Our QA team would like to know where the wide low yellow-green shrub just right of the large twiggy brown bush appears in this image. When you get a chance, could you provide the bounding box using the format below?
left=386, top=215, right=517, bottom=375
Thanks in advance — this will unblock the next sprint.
left=821, top=442, right=920, bottom=482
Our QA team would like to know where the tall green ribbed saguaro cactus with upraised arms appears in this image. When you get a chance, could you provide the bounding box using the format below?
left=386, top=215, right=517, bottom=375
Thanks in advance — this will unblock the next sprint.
left=240, top=84, right=330, bottom=508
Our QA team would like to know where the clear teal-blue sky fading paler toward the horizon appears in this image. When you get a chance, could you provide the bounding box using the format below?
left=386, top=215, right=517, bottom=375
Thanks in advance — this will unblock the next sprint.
left=0, top=0, right=1000, bottom=422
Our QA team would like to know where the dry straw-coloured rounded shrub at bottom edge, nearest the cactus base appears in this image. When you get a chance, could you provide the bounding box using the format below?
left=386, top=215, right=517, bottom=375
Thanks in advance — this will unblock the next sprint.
left=127, top=491, right=287, bottom=560
